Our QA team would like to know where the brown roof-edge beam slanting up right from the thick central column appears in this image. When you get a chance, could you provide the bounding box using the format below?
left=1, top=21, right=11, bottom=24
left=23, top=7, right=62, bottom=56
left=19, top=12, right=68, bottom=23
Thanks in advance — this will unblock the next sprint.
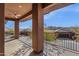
left=44, top=3, right=73, bottom=14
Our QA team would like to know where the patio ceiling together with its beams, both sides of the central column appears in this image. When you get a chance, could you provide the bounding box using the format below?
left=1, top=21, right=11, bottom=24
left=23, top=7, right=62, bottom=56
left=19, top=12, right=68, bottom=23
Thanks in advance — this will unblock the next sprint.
left=5, top=3, right=71, bottom=21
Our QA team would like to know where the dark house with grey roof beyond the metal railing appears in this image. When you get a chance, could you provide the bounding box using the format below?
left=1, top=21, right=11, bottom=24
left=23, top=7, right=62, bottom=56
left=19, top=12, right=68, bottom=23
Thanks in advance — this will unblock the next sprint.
left=55, top=29, right=75, bottom=39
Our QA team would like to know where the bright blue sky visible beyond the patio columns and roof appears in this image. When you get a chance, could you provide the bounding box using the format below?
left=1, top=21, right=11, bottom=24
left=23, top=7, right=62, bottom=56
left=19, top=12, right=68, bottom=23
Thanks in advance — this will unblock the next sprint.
left=6, top=3, right=79, bottom=28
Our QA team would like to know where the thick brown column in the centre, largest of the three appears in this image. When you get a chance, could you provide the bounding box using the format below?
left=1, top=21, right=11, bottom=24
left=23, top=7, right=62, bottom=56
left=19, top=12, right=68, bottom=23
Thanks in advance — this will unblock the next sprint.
left=32, top=3, right=44, bottom=53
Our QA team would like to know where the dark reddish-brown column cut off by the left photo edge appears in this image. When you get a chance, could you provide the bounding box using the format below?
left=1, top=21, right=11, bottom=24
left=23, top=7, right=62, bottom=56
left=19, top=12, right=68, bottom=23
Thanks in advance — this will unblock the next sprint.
left=0, top=3, right=4, bottom=56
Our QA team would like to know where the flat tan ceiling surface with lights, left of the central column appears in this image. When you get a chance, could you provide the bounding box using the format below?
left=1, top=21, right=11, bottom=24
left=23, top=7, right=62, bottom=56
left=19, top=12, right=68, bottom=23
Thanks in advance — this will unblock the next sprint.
left=5, top=3, right=32, bottom=20
